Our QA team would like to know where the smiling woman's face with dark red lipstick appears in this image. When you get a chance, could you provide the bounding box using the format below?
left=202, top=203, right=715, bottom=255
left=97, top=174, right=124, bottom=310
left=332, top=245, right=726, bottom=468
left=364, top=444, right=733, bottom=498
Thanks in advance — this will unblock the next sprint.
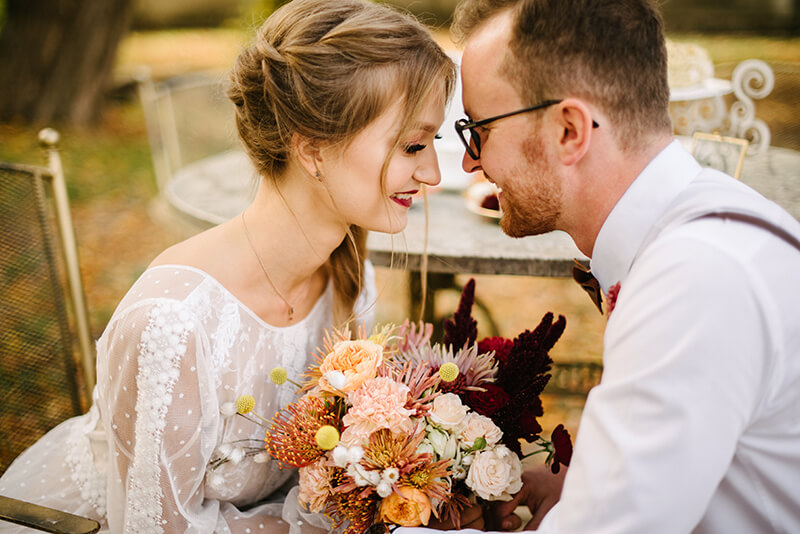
left=323, top=90, right=445, bottom=233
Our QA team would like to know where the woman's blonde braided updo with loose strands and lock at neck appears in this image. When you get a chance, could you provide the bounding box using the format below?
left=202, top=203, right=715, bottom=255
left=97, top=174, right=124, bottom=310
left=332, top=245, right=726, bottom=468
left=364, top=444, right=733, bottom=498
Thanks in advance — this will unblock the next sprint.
left=228, top=0, right=456, bottom=324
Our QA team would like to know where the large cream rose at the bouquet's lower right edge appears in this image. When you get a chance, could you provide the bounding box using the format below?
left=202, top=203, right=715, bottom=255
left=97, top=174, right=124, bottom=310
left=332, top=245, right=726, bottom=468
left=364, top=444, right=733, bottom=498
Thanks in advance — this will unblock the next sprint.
left=465, top=445, right=522, bottom=501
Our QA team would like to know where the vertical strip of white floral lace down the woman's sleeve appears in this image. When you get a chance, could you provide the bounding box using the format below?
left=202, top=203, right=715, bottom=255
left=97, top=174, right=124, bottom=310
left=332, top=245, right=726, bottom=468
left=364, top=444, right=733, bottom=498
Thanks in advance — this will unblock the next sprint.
left=125, top=302, right=192, bottom=534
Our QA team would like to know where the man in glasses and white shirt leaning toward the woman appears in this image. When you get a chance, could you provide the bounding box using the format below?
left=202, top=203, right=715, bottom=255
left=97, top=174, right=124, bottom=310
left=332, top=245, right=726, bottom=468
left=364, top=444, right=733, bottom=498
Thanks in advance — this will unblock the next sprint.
left=404, top=0, right=800, bottom=534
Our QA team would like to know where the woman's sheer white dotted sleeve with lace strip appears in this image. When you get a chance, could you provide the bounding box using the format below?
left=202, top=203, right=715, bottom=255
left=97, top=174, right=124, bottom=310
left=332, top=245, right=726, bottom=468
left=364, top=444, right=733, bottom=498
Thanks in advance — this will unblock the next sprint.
left=98, top=299, right=225, bottom=533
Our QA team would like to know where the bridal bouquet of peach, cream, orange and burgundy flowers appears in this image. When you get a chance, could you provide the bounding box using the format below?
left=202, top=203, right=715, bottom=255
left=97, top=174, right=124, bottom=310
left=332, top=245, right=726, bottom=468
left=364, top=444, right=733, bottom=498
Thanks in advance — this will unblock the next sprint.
left=266, top=280, right=572, bottom=534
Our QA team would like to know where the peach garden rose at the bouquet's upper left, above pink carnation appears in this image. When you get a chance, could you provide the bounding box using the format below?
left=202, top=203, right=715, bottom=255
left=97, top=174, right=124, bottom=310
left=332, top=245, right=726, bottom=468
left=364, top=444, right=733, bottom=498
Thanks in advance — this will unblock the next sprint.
left=319, top=339, right=383, bottom=393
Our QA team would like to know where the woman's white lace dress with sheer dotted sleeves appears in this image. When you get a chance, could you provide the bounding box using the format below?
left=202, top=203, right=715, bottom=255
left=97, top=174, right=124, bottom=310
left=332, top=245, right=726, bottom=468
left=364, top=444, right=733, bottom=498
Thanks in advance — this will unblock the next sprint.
left=0, top=262, right=376, bottom=534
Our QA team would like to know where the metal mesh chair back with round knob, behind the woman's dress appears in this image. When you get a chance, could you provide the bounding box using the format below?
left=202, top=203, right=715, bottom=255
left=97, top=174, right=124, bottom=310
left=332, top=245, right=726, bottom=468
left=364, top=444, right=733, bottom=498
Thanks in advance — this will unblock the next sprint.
left=0, top=129, right=95, bottom=473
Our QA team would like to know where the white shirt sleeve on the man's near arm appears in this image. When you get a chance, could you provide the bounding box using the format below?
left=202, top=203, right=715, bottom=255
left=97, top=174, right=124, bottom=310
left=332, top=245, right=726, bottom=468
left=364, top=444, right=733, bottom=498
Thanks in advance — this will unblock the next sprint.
left=396, top=227, right=769, bottom=534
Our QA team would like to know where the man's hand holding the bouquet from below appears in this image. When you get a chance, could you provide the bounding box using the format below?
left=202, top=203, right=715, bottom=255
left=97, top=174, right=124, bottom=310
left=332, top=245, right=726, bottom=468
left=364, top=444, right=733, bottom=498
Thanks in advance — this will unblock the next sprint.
left=490, top=465, right=567, bottom=530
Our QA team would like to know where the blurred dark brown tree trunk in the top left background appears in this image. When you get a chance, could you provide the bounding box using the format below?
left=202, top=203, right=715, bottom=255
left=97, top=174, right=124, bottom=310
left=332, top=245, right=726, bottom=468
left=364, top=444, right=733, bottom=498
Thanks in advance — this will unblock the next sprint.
left=0, top=0, right=133, bottom=125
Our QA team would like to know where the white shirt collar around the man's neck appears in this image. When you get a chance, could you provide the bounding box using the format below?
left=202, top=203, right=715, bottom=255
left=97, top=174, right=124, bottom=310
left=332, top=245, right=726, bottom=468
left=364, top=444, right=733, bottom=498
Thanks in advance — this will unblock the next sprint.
left=591, top=140, right=702, bottom=293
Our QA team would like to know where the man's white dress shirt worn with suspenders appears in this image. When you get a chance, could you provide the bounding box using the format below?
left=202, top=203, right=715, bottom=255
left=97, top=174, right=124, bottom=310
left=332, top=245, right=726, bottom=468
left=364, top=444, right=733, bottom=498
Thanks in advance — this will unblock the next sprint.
left=395, top=142, right=800, bottom=534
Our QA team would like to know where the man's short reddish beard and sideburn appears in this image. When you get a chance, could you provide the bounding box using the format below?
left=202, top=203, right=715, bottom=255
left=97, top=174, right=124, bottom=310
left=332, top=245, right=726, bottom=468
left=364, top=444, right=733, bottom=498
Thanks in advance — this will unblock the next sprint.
left=500, top=137, right=562, bottom=237
